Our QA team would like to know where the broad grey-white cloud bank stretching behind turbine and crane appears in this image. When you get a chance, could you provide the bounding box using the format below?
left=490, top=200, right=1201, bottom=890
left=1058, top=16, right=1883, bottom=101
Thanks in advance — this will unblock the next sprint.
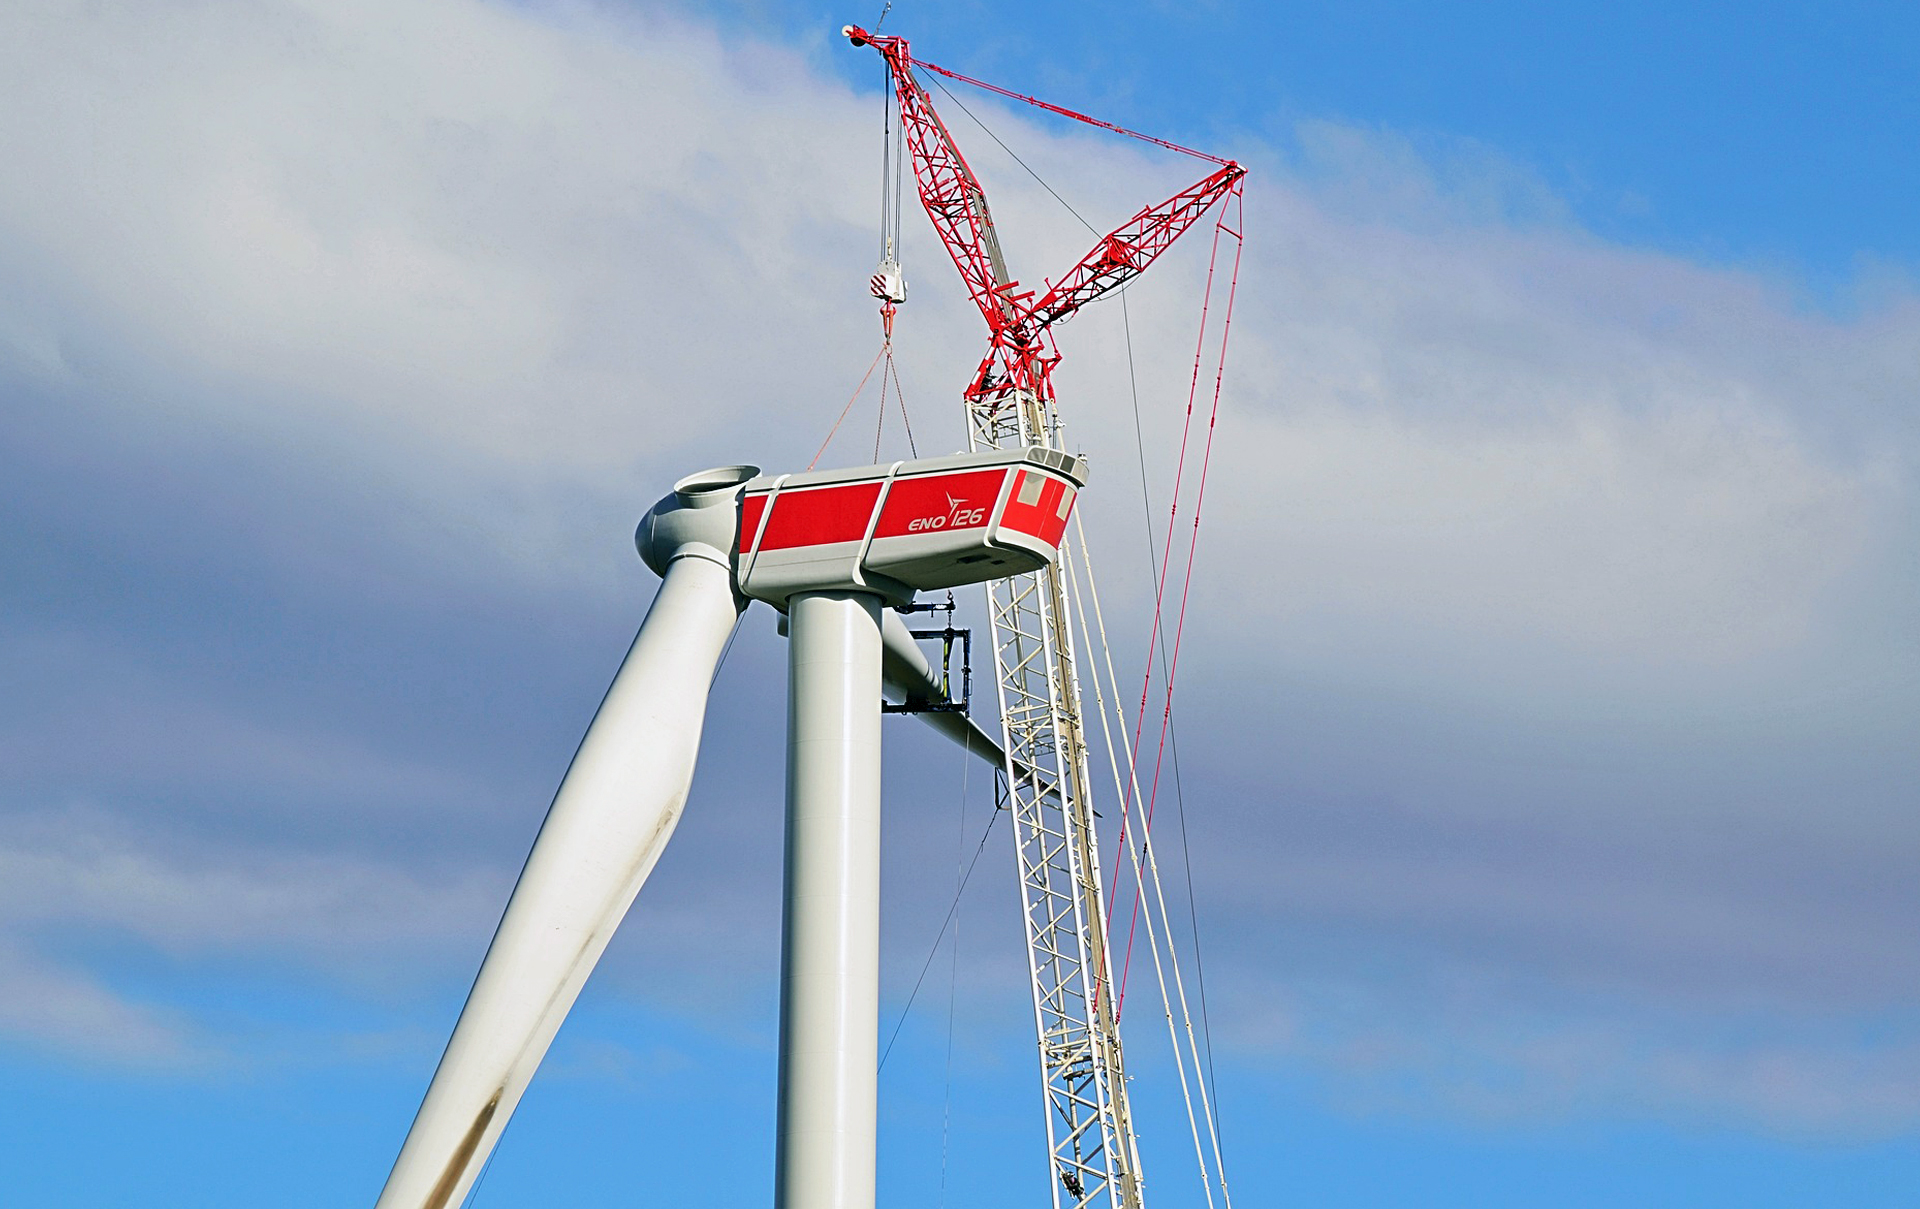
left=0, top=0, right=1920, bottom=1130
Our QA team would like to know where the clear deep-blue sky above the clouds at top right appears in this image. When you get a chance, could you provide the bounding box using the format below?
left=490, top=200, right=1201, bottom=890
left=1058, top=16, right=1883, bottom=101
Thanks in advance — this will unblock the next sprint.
left=744, top=0, right=1920, bottom=290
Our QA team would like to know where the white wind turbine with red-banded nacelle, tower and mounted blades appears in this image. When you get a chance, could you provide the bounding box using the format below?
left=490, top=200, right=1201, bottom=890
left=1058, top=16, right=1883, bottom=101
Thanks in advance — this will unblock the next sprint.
left=378, top=449, right=1085, bottom=1209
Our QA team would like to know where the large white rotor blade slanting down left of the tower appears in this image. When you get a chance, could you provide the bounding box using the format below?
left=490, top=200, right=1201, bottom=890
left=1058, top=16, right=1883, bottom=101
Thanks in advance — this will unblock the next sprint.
left=376, top=552, right=741, bottom=1209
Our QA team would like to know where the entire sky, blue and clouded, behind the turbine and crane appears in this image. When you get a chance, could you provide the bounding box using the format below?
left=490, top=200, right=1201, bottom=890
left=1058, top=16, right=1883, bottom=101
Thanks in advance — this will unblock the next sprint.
left=0, top=0, right=1920, bottom=1207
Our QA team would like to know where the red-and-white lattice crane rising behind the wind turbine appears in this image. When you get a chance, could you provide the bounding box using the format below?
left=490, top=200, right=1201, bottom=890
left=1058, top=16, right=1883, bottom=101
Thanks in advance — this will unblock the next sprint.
left=843, top=25, right=1246, bottom=1209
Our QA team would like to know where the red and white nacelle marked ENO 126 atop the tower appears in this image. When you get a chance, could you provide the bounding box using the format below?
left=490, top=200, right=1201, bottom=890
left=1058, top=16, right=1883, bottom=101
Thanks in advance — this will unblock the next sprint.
left=735, top=447, right=1087, bottom=608
